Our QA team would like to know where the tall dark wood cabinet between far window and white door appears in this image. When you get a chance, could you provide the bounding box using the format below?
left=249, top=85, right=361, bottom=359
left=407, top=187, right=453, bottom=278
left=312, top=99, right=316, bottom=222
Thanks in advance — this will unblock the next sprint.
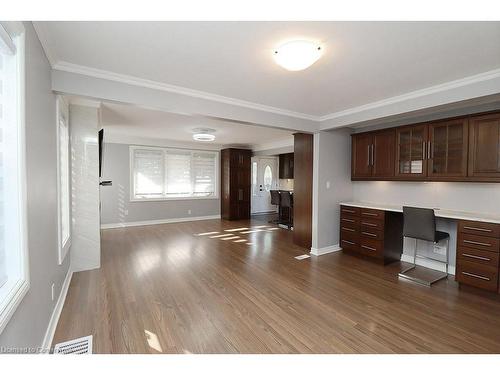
left=221, top=148, right=251, bottom=220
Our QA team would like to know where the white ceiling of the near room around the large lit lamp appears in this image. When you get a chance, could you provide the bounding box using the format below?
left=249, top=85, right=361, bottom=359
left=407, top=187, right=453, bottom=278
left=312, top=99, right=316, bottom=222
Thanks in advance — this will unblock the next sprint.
left=35, top=22, right=500, bottom=116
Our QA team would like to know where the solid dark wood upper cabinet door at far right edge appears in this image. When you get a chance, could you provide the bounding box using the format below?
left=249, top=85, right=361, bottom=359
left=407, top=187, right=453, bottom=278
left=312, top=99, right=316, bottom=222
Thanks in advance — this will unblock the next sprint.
left=468, top=114, right=500, bottom=179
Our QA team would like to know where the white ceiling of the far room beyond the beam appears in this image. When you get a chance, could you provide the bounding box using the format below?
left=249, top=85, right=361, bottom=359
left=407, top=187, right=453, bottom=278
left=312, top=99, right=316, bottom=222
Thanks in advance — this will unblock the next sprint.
left=101, top=103, right=293, bottom=148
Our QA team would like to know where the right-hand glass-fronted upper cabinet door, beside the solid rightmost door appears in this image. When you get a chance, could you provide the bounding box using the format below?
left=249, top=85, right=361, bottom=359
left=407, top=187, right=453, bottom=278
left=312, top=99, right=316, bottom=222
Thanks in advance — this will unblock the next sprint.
left=427, top=119, right=468, bottom=179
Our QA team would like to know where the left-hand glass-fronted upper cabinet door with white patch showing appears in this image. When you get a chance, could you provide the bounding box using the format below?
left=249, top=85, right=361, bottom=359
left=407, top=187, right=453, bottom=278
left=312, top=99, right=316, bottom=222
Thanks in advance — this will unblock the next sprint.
left=396, top=125, right=427, bottom=179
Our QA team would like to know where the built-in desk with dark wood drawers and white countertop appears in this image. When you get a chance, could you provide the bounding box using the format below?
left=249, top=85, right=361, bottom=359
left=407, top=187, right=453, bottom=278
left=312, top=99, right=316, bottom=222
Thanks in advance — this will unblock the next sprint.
left=340, top=202, right=500, bottom=292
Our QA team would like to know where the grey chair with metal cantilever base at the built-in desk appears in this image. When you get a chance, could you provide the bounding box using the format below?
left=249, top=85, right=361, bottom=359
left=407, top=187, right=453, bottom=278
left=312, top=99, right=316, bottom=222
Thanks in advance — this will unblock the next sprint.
left=399, top=207, right=450, bottom=286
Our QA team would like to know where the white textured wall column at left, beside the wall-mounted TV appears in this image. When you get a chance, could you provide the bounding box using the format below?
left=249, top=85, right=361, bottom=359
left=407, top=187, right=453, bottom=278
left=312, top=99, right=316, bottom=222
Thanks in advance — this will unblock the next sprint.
left=69, top=105, right=101, bottom=271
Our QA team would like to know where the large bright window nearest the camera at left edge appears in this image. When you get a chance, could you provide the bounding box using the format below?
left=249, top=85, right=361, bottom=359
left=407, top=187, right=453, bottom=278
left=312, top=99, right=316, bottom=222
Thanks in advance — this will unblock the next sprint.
left=0, top=23, right=29, bottom=332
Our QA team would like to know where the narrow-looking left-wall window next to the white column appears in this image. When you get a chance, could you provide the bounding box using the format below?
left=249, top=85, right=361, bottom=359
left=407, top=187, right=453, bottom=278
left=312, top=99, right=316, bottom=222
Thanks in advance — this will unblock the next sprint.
left=57, top=97, right=71, bottom=264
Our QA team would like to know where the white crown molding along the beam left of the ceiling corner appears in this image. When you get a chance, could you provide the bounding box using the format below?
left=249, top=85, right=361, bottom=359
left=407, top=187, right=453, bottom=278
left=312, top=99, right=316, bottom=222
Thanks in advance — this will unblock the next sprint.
left=53, top=61, right=319, bottom=121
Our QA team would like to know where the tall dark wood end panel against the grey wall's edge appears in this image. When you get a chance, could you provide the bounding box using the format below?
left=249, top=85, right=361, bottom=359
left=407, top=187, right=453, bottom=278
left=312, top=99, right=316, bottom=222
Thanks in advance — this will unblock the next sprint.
left=293, top=133, right=313, bottom=250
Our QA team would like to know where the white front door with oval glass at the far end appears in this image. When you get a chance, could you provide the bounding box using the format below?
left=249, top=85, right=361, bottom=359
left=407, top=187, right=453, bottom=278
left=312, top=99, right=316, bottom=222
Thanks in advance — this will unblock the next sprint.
left=251, top=156, right=278, bottom=213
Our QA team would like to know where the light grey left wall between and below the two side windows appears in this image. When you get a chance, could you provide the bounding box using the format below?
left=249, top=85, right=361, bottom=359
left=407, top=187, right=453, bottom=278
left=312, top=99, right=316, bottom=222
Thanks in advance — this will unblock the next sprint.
left=0, top=22, right=71, bottom=348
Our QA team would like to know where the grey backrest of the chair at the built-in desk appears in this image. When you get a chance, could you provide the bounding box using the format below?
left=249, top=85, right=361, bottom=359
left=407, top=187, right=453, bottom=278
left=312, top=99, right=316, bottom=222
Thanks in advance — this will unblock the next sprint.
left=403, top=206, right=436, bottom=242
